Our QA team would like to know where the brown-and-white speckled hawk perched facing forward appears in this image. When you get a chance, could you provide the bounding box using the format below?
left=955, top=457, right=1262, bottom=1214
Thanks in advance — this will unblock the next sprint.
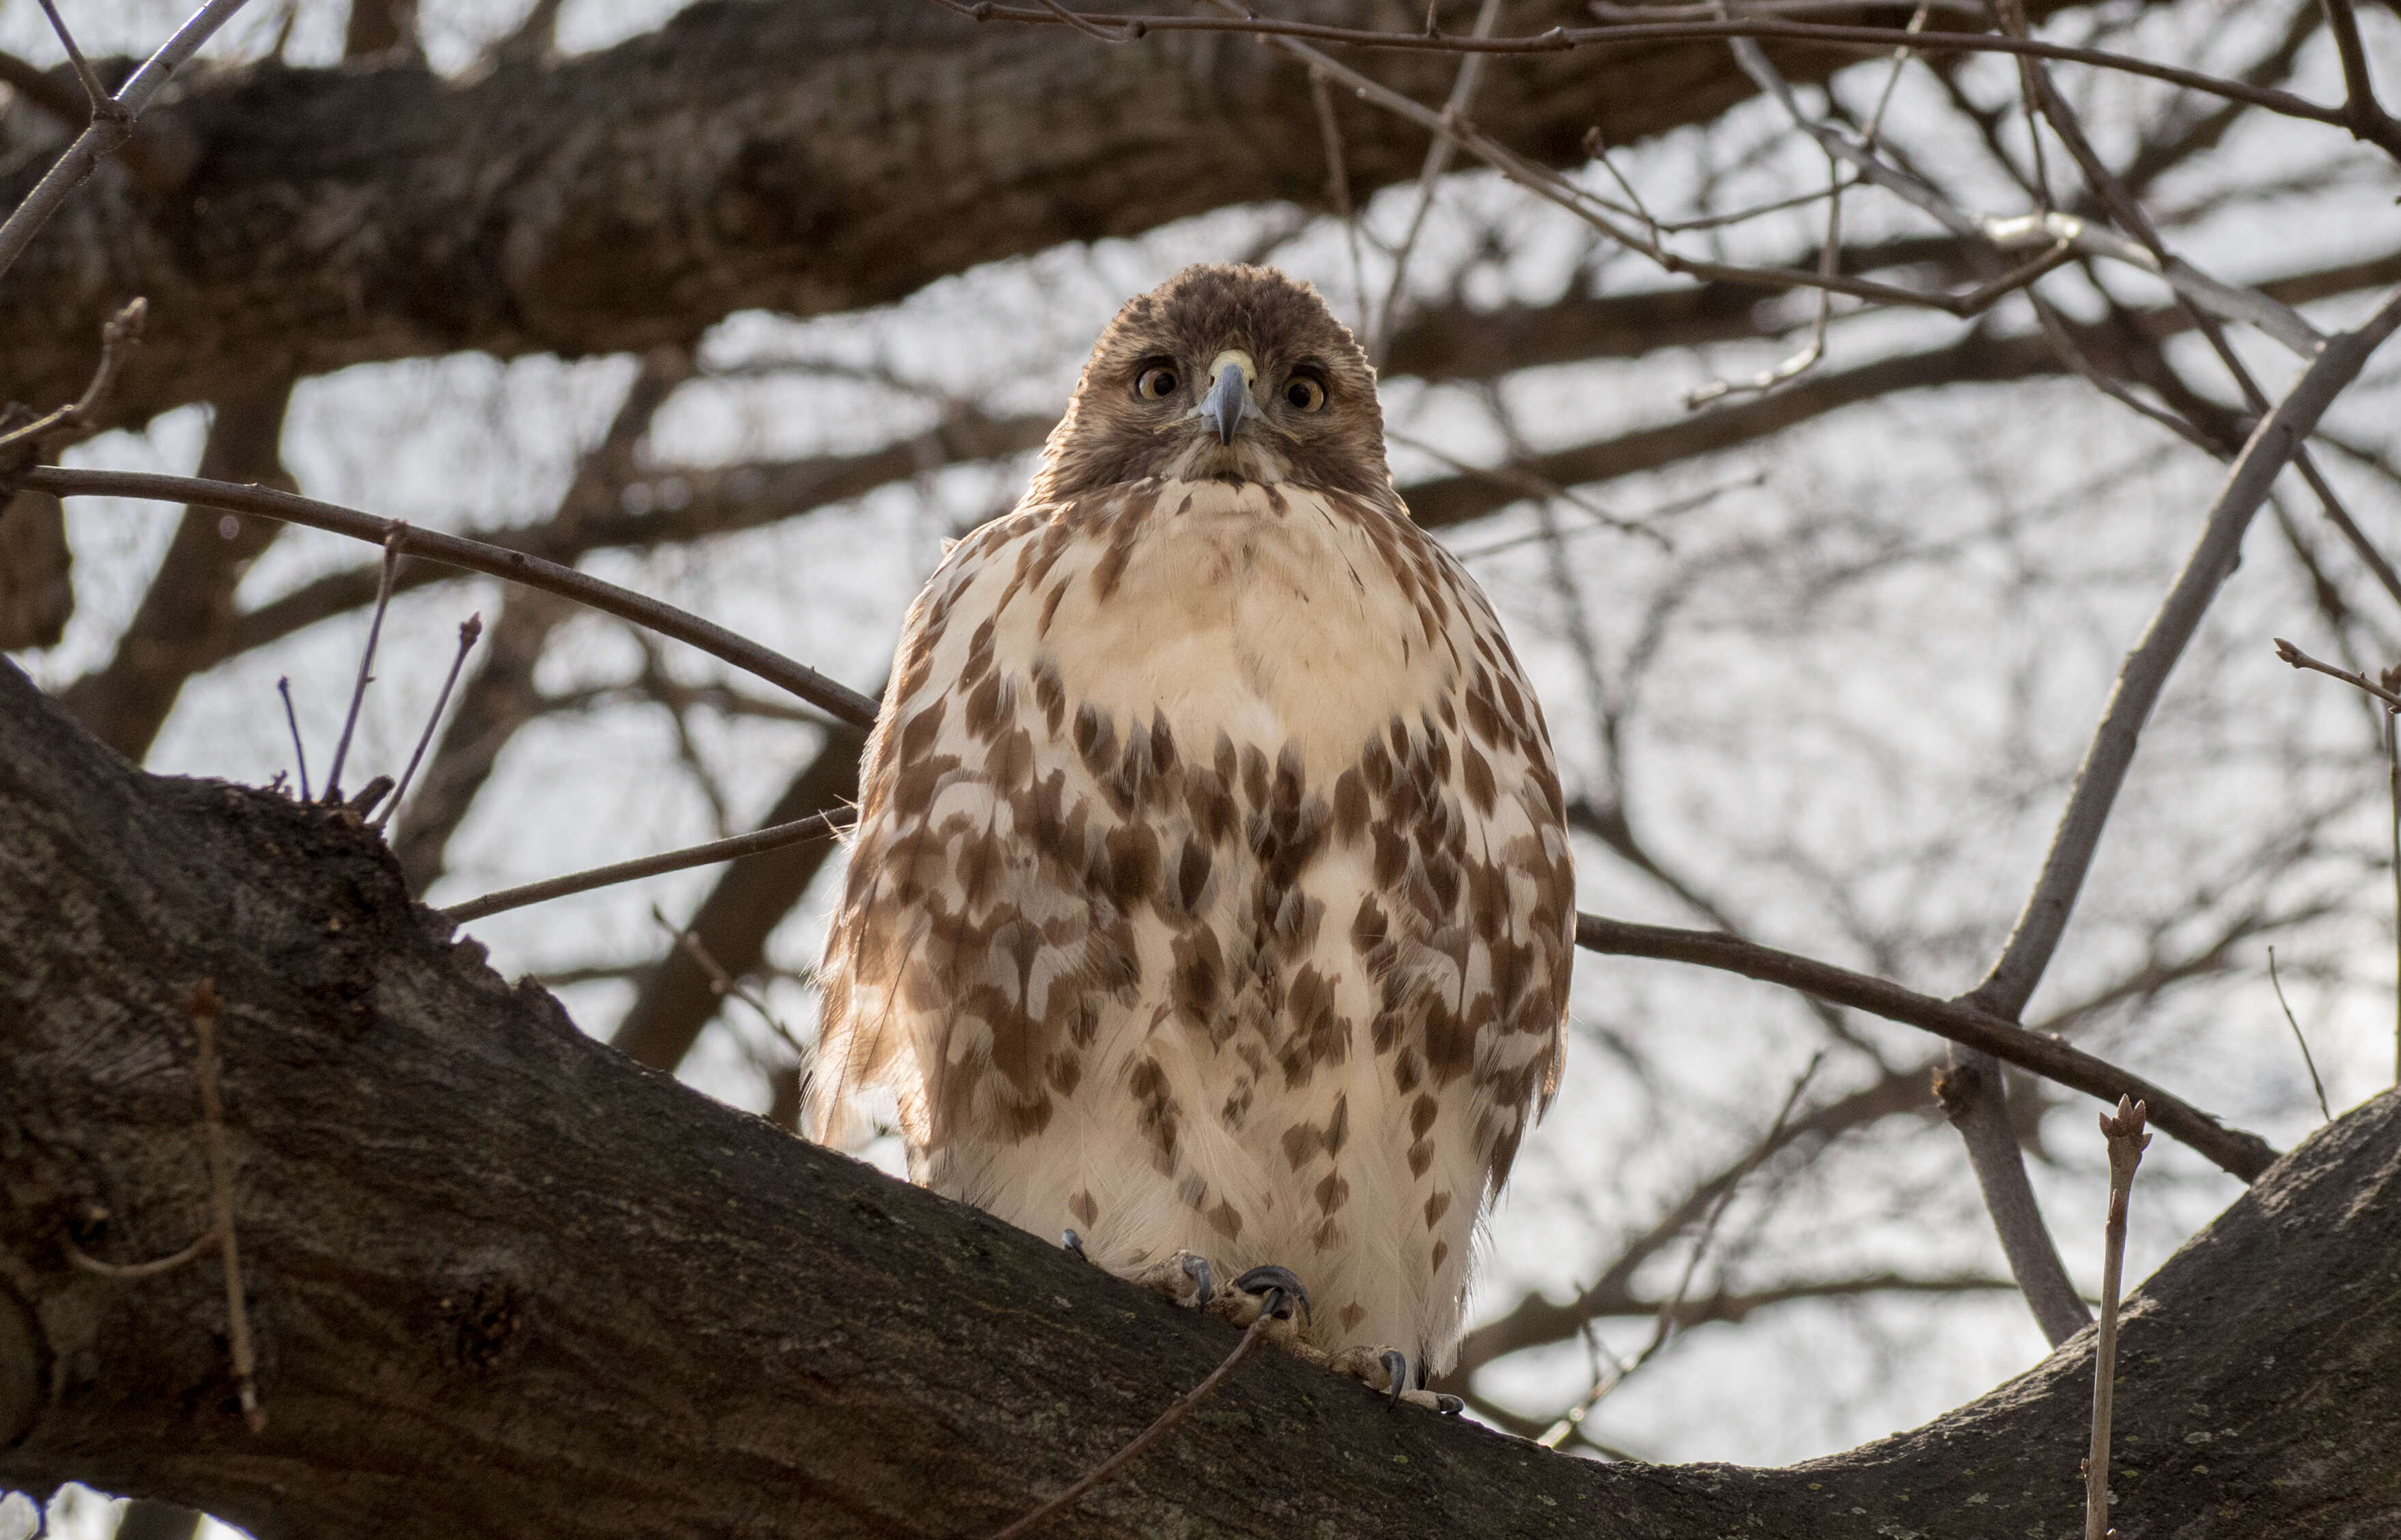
left=809, top=266, right=1575, bottom=1405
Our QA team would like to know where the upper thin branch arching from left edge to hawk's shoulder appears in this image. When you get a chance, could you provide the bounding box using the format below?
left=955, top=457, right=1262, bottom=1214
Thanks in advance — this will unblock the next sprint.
left=19, top=466, right=876, bottom=728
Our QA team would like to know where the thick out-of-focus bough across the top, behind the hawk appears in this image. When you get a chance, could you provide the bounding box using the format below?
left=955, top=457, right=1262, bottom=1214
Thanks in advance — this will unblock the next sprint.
left=0, top=0, right=2043, bottom=421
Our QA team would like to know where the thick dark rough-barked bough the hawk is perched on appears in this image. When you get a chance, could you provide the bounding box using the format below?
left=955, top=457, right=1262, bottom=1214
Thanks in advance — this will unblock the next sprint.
left=0, top=653, right=2401, bottom=1540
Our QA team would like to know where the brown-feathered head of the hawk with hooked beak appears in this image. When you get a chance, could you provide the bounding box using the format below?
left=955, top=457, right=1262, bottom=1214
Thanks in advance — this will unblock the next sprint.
left=1035, top=264, right=1392, bottom=500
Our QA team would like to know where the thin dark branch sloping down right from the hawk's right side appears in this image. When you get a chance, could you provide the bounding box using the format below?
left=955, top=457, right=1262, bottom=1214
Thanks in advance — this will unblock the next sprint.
left=1575, top=913, right=2276, bottom=1182
